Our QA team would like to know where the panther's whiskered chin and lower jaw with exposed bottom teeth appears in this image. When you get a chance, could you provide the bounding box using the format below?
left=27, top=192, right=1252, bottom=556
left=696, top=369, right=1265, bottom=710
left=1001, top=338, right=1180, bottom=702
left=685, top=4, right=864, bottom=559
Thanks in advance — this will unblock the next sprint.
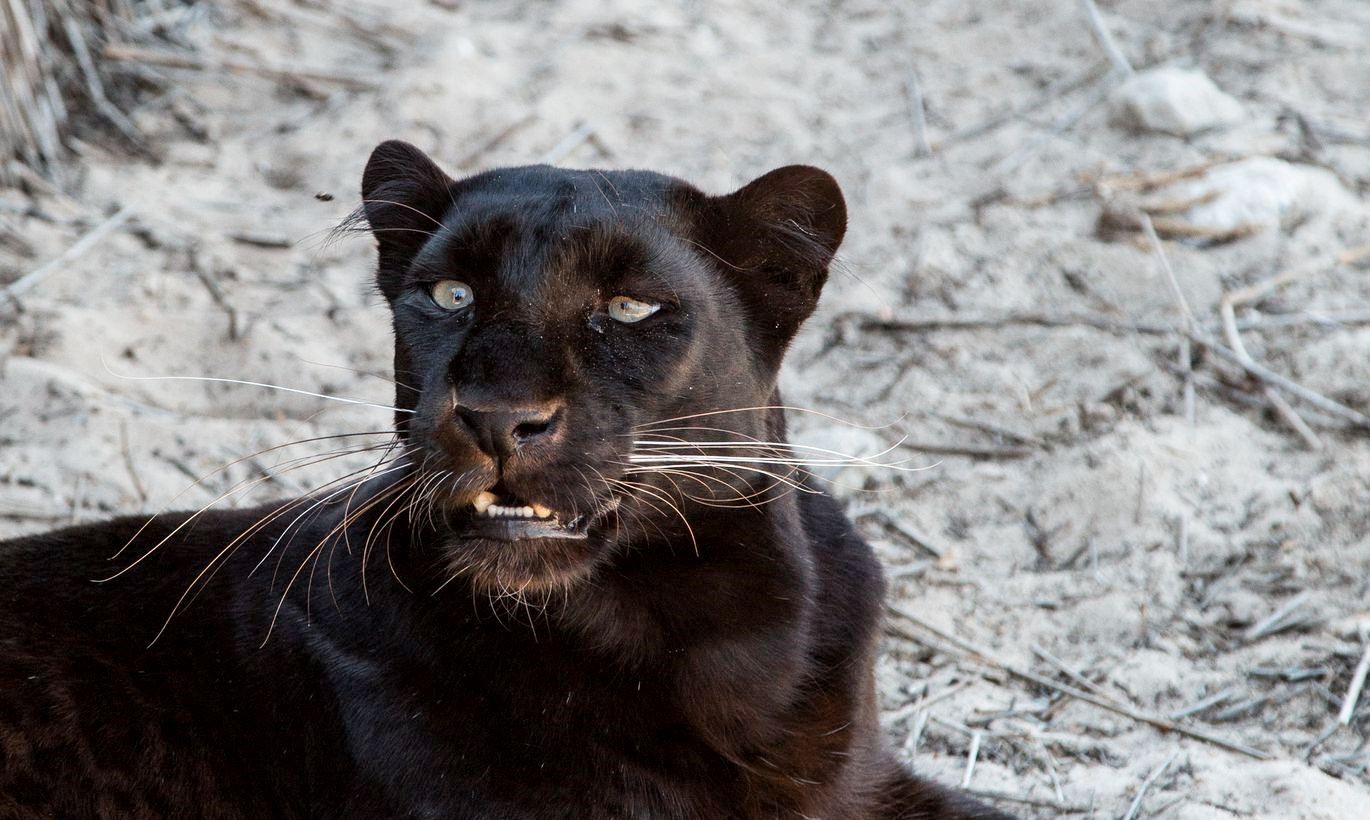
left=448, top=491, right=617, bottom=598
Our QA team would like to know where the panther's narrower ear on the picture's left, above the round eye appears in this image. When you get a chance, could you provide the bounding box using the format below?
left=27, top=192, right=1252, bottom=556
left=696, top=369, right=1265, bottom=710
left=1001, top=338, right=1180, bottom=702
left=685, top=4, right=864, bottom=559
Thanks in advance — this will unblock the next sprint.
left=362, top=140, right=455, bottom=296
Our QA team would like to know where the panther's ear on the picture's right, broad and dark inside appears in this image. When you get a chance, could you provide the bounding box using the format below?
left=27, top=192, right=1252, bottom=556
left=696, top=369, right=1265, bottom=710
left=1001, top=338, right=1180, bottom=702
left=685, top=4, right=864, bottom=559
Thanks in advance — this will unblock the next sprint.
left=700, top=166, right=847, bottom=353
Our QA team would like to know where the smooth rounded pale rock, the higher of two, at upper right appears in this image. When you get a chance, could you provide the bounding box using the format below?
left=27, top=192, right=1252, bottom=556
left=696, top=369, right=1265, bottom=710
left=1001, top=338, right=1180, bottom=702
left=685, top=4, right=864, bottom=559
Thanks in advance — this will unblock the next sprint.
left=1110, top=67, right=1245, bottom=137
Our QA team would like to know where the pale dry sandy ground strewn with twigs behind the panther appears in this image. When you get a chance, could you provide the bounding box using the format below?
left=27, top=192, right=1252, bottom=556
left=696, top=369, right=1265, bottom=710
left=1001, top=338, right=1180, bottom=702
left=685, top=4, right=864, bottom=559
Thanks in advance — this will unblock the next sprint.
left=0, top=0, right=1370, bottom=819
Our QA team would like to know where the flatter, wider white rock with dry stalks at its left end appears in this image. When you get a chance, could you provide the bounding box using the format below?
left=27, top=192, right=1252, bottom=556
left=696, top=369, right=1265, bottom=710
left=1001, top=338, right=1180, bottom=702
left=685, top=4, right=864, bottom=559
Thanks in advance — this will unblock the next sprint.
left=1163, top=156, right=1360, bottom=230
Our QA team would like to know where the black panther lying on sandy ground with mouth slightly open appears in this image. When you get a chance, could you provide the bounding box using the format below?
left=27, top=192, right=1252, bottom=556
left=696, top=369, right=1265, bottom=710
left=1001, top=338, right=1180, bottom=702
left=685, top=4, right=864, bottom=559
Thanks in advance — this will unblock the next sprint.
left=0, top=142, right=1003, bottom=819
